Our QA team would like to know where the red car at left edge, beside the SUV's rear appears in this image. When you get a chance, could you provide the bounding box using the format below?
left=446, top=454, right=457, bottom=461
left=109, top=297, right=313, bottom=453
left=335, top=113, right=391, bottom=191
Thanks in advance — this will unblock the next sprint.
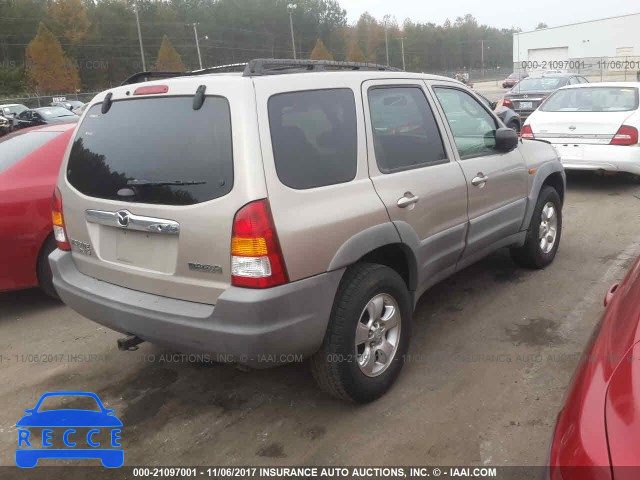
left=0, top=123, right=76, bottom=297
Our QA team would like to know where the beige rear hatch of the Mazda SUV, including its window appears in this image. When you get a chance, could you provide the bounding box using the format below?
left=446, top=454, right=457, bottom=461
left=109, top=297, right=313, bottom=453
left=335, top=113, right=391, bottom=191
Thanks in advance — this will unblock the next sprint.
left=59, top=76, right=266, bottom=304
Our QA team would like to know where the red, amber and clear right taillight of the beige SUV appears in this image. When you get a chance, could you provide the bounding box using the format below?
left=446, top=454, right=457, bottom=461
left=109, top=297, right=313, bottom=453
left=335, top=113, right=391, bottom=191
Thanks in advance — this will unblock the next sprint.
left=231, top=200, right=289, bottom=288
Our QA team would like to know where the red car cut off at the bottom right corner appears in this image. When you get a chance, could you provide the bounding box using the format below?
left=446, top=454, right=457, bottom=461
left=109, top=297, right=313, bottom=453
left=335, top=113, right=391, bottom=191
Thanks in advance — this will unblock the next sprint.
left=549, top=259, right=640, bottom=480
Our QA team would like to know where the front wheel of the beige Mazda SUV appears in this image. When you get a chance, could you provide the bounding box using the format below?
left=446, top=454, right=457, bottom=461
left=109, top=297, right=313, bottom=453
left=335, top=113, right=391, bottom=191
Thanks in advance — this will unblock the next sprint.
left=511, top=185, right=562, bottom=269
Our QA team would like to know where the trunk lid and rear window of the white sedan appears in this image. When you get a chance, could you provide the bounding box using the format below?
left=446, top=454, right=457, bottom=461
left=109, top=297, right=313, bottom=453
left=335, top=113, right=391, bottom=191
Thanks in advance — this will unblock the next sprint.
left=529, top=86, right=638, bottom=145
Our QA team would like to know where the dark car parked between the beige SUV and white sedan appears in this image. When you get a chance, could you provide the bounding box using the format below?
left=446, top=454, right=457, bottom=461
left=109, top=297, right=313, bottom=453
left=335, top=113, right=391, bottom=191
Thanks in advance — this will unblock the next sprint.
left=504, top=73, right=589, bottom=122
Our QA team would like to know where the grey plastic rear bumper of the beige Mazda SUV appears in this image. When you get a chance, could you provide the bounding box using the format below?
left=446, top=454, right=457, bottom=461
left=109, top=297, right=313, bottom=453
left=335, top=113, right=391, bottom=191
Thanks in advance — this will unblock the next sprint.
left=49, top=250, right=344, bottom=368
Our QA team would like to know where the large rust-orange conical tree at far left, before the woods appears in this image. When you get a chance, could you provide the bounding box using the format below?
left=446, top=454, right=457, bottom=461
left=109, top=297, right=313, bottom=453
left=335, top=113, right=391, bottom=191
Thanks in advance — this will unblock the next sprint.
left=26, top=22, right=80, bottom=94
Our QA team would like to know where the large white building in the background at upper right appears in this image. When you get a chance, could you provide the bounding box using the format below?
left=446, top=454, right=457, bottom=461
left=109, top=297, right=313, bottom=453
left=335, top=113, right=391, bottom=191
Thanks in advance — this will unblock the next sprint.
left=513, top=13, right=640, bottom=70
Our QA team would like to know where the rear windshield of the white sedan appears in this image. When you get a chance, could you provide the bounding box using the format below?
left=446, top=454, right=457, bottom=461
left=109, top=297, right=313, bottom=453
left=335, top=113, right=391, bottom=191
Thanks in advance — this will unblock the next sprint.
left=540, top=87, right=638, bottom=112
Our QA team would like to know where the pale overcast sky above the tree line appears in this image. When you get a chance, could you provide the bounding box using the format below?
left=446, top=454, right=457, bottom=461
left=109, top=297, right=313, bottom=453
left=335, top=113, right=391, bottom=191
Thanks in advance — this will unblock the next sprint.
left=339, top=0, right=640, bottom=31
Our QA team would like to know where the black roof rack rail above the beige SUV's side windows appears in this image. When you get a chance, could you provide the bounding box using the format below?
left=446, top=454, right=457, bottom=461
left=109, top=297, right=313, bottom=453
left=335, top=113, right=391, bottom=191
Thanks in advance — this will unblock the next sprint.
left=242, top=58, right=402, bottom=77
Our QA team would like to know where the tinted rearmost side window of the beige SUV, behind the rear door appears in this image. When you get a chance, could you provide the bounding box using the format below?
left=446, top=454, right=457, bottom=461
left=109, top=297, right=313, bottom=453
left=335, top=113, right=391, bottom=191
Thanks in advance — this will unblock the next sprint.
left=269, top=88, right=358, bottom=190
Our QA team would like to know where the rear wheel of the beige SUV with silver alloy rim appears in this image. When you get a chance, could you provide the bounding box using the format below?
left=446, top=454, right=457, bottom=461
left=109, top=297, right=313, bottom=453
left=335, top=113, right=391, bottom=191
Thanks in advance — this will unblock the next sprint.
left=310, top=263, right=413, bottom=403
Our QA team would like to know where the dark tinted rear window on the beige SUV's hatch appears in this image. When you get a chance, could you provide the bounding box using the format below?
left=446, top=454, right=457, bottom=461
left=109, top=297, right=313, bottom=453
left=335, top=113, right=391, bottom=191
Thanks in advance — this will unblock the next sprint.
left=67, top=97, right=233, bottom=205
